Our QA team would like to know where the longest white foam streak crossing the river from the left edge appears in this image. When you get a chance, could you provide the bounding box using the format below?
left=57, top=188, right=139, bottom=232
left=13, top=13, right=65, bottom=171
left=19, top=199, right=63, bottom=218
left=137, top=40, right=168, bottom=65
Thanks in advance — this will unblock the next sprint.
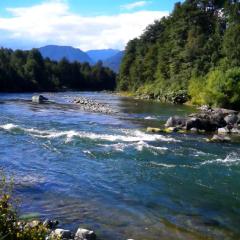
left=0, top=124, right=179, bottom=142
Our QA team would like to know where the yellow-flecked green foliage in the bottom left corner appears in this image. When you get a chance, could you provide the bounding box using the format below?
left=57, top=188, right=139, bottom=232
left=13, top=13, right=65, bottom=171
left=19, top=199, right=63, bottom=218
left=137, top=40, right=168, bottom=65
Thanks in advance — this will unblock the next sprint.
left=0, top=174, right=48, bottom=240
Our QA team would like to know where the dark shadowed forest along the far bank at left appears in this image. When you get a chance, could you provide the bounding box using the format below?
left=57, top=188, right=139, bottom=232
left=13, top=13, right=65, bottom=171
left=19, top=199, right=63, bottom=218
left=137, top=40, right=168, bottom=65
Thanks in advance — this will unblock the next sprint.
left=0, top=48, right=116, bottom=92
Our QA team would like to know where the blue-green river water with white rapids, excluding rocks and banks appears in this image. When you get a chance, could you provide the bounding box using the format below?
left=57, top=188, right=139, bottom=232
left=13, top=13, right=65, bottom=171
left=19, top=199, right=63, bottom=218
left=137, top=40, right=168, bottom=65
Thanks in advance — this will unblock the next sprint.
left=0, top=92, right=240, bottom=240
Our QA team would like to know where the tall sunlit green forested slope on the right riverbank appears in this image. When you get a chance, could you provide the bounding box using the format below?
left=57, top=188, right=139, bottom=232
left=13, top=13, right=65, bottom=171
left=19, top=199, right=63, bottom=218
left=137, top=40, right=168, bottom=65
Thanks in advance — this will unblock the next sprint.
left=118, top=0, right=240, bottom=109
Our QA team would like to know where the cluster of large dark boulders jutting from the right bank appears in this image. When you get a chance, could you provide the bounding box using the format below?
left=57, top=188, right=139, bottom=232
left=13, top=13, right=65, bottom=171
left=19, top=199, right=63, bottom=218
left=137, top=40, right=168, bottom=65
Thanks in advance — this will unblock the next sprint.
left=147, top=106, right=240, bottom=142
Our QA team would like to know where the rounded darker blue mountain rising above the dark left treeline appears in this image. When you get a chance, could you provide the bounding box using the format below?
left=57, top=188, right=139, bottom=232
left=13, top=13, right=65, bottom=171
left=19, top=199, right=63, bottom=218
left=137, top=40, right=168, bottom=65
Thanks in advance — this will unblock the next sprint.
left=39, top=45, right=93, bottom=64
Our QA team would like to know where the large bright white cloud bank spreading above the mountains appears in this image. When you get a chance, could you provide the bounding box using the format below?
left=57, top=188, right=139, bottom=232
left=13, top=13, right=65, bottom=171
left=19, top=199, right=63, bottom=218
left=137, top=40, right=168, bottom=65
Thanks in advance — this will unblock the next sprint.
left=0, top=0, right=168, bottom=50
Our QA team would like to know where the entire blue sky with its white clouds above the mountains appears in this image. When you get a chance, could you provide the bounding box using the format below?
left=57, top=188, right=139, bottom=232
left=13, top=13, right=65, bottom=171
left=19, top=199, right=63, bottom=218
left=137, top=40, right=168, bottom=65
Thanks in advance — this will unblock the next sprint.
left=0, top=0, right=181, bottom=50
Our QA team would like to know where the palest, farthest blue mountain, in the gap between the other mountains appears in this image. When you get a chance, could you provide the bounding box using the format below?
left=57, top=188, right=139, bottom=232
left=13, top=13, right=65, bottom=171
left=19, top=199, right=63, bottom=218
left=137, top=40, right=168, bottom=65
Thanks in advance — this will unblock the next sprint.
left=86, top=49, right=120, bottom=63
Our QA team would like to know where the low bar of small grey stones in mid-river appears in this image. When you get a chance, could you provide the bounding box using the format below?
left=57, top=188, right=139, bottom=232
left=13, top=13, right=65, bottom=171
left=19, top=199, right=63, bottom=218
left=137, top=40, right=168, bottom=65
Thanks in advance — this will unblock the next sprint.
left=73, top=97, right=116, bottom=114
